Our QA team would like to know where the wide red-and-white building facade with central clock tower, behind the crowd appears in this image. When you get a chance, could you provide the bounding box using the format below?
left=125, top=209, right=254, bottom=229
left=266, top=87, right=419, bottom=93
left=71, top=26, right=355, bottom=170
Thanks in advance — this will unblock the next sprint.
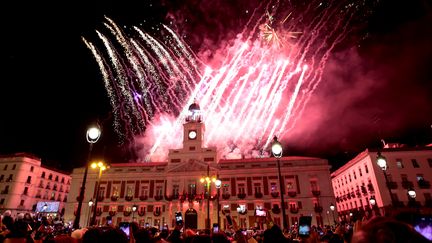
left=64, top=104, right=336, bottom=229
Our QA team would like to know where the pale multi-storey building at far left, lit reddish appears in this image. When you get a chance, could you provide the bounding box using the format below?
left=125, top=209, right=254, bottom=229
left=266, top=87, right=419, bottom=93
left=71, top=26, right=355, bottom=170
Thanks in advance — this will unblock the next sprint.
left=0, top=154, right=71, bottom=215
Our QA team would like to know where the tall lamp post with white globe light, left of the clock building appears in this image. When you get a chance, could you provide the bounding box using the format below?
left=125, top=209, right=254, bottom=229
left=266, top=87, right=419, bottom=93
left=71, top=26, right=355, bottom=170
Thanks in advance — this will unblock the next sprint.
left=73, top=125, right=101, bottom=229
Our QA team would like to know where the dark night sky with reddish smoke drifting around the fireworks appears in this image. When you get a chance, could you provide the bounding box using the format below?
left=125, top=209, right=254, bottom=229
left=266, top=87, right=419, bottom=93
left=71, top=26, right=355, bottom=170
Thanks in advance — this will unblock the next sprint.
left=0, top=0, right=432, bottom=170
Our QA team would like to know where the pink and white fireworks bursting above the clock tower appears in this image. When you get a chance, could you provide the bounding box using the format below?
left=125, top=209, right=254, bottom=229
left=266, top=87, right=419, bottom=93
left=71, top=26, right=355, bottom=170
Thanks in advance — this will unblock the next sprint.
left=85, top=1, right=368, bottom=161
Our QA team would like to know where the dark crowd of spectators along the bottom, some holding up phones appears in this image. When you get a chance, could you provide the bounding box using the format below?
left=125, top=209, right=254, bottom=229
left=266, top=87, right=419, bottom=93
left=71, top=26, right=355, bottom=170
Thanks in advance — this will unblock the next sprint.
left=0, top=211, right=430, bottom=243
